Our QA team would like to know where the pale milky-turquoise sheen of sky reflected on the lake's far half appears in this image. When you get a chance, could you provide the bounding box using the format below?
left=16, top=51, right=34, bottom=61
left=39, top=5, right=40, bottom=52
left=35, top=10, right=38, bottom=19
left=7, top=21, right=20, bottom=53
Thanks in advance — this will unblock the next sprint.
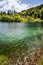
left=0, top=23, right=40, bottom=41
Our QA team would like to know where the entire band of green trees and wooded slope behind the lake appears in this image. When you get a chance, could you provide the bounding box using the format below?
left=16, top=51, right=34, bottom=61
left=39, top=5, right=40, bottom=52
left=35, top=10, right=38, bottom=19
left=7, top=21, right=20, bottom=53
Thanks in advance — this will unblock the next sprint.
left=0, top=4, right=43, bottom=22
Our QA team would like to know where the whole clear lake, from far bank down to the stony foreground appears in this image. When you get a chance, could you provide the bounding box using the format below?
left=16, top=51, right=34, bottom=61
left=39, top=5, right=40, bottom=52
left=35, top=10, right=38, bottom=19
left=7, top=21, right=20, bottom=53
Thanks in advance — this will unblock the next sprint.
left=0, top=22, right=43, bottom=65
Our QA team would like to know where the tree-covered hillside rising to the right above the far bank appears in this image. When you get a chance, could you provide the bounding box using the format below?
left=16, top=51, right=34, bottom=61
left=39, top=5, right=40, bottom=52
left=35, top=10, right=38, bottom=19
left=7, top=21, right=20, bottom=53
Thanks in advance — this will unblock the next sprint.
left=19, top=4, right=43, bottom=21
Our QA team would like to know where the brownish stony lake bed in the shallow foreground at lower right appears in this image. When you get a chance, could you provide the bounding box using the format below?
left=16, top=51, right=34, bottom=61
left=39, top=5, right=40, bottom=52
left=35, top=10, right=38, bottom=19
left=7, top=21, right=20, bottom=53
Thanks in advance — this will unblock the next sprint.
left=8, top=48, right=43, bottom=65
